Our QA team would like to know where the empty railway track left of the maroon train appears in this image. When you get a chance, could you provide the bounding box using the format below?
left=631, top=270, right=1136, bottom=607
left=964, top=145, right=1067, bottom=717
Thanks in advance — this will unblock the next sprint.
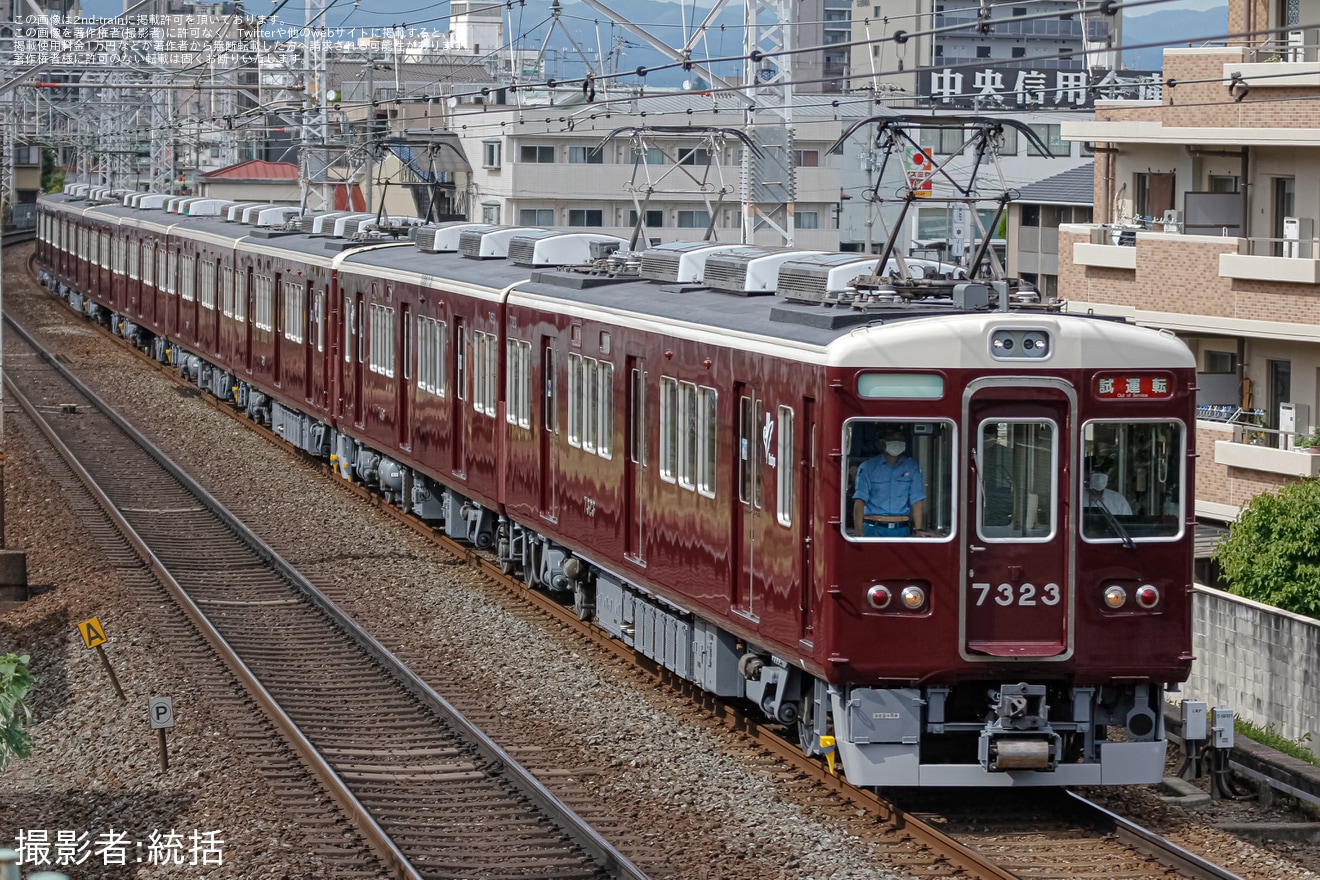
left=5, top=311, right=645, bottom=879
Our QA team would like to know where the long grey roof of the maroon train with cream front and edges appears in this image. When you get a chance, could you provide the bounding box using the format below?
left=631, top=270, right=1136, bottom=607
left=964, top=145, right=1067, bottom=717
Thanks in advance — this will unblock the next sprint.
left=44, top=195, right=1195, bottom=369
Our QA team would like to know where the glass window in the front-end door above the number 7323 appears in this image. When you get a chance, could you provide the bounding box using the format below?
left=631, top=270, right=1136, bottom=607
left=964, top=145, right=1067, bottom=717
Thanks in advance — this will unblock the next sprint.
left=975, top=421, right=1059, bottom=542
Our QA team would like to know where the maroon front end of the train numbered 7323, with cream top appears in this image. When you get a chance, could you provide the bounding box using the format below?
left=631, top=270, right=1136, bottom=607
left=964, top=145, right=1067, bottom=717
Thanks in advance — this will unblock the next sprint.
left=803, top=310, right=1195, bottom=786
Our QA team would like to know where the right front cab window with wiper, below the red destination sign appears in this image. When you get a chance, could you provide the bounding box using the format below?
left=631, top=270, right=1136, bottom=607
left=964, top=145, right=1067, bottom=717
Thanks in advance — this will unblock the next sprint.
left=1081, top=421, right=1185, bottom=542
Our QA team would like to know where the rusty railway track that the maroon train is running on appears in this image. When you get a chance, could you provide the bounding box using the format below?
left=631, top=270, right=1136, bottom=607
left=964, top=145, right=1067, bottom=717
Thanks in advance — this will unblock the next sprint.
left=10, top=244, right=1261, bottom=880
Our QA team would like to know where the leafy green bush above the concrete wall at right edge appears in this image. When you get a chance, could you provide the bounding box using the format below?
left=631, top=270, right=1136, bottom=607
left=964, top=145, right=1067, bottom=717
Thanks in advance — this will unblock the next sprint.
left=1214, top=479, right=1320, bottom=617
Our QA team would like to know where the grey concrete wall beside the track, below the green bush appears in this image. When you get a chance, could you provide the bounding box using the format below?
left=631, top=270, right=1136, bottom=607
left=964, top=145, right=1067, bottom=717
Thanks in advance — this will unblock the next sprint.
left=1183, top=586, right=1320, bottom=749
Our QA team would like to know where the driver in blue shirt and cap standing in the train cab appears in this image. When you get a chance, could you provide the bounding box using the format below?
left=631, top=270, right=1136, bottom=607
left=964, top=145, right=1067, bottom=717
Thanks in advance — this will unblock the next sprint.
left=853, top=427, right=929, bottom=538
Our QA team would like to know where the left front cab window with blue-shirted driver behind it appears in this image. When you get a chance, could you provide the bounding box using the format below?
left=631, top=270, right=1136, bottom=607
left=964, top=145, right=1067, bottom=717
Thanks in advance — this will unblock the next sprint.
left=844, top=418, right=957, bottom=541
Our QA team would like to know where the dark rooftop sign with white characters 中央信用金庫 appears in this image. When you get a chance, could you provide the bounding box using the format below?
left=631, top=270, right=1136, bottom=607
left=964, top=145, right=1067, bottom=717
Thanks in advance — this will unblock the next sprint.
left=917, top=65, right=1164, bottom=110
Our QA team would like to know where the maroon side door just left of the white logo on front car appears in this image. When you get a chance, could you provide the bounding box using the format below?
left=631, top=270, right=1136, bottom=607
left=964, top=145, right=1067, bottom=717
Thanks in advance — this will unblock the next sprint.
left=733, top=383, right=764, bottom=620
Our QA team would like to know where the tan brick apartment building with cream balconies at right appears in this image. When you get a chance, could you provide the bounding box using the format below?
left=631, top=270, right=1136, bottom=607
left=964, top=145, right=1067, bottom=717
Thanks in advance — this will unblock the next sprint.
left=1059, top=0, right=1320, bottom=520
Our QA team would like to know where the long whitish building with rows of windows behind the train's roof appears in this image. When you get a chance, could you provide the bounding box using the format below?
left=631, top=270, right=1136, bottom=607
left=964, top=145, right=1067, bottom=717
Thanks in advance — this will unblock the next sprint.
left=453, top=92, right=843, bottom=251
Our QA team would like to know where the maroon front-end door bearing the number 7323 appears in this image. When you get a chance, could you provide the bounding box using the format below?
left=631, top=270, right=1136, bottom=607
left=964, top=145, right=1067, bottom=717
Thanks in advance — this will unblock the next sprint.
left=960, top=377, right=1076, bottom=661
